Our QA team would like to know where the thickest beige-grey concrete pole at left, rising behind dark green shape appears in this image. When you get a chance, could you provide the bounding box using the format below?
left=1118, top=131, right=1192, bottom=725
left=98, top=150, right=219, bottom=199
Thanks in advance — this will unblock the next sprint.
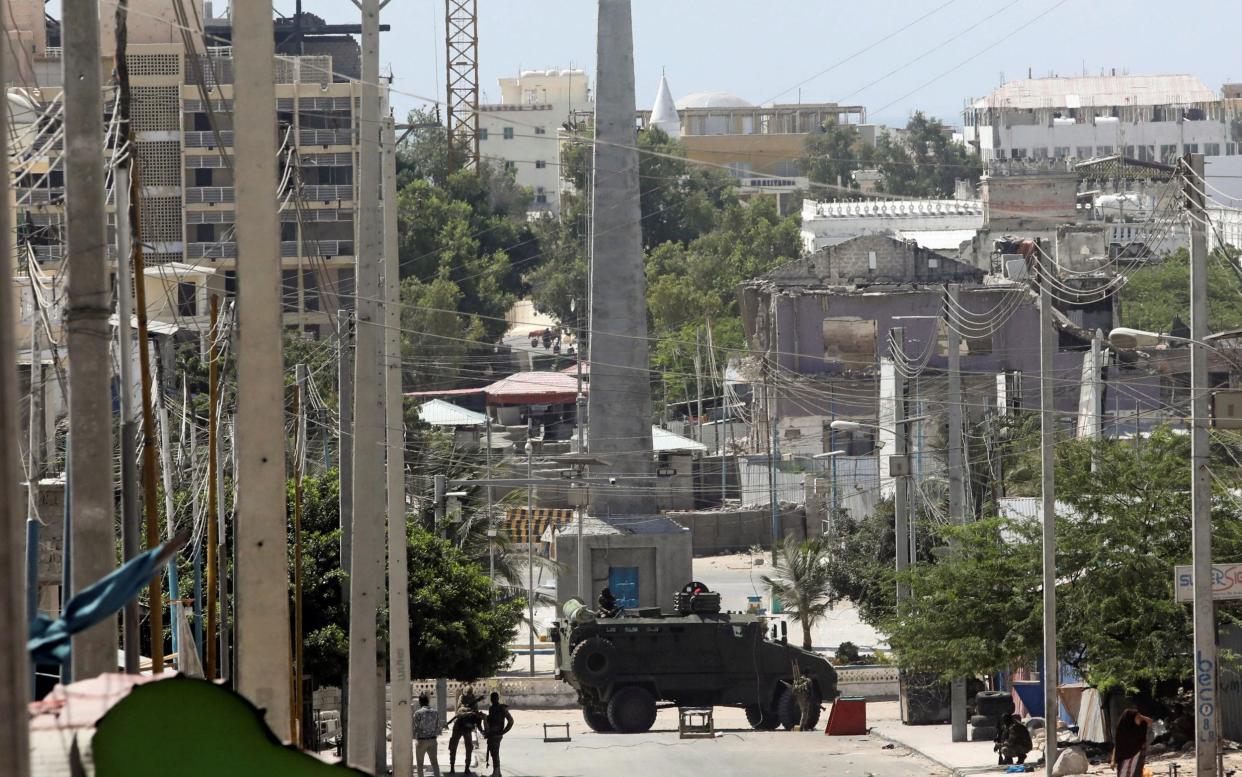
left=232, top=2, right=292, bottom=742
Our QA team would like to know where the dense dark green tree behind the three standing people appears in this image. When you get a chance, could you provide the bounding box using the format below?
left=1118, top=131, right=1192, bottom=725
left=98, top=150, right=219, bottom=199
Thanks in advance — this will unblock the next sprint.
left=409, top=526, right=525, bottom=680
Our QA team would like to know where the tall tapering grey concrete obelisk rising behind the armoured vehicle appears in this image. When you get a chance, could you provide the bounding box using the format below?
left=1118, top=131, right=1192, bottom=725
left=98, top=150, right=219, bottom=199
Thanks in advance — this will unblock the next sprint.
left=587, top=0, right=655, bottom=515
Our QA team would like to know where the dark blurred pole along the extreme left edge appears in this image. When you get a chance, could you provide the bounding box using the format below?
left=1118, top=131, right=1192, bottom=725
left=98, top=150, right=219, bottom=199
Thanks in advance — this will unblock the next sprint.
left=0, top=27, right=30, bottom=777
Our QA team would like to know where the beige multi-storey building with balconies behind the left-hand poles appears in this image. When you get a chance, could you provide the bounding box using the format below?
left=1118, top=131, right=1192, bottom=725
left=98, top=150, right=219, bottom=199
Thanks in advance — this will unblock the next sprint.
left=15, top=0, right=372, bottom=335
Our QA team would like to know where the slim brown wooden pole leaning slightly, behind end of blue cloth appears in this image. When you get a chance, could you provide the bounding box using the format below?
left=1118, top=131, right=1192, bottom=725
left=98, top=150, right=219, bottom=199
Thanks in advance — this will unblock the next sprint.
left=129, top=166, right=164, bottom=674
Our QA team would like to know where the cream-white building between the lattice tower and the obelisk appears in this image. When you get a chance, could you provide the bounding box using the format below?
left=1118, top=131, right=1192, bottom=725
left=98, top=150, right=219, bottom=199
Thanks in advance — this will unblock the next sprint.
left=478, top=70, right=595, bottom=213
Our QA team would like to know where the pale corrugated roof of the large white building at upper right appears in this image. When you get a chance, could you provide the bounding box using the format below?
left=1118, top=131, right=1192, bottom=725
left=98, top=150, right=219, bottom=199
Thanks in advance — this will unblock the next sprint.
left=974, top=76, right=1218, bottom=108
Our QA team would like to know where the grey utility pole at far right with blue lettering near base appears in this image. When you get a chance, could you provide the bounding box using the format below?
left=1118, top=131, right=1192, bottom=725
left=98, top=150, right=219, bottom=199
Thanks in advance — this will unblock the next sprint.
left=1182, top=154, right=1221, bottom=777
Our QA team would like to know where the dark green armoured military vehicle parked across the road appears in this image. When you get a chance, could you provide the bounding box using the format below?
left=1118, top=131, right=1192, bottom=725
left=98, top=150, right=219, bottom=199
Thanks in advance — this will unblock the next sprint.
left=551, top=583, right=837, bottom=734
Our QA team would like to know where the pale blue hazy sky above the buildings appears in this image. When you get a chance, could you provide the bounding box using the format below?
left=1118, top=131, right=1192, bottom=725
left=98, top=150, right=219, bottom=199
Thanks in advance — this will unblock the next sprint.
left=262, top=0, right=1242, bottom=123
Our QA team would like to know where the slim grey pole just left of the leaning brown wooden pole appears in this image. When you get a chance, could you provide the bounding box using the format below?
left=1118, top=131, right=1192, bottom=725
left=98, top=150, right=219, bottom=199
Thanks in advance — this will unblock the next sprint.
left=116, top=164, right=141, bottom=674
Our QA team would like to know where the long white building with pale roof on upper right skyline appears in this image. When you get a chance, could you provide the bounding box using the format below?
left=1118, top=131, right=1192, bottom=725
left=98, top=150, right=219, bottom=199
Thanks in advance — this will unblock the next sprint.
left=964, top=76, right=1242, bottom=163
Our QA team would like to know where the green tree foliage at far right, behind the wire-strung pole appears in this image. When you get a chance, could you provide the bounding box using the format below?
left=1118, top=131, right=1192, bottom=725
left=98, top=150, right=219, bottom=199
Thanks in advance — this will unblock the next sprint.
left=1120, top=248, right=1242, bottom=333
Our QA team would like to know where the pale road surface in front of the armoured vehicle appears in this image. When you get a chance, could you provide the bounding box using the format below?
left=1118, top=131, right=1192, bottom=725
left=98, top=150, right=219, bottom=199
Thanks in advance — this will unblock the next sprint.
left=486, top=707, right=945, bottom=777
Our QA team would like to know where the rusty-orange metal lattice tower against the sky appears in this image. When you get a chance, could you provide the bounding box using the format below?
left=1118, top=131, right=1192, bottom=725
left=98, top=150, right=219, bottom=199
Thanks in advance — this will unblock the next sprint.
left=445, top=0, right=478, bottom=168
